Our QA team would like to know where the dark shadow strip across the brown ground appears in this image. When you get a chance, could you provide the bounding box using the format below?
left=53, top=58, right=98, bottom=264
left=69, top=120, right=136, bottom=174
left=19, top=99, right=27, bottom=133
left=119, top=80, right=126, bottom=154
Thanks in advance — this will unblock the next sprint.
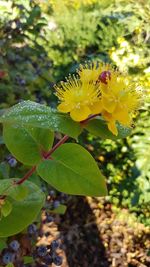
left=58, top=197, right=110, bottom=267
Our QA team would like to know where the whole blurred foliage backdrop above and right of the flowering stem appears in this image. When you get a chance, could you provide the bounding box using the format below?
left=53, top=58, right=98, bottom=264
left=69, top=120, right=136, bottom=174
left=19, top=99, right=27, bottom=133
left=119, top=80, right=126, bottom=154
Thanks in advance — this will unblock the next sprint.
left=0, top=0, right=150, bottom=224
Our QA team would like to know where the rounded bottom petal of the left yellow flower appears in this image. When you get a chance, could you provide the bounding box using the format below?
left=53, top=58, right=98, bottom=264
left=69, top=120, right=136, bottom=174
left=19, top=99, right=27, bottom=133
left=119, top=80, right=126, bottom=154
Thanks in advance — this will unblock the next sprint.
left=70, top=106, right=91, bottom=121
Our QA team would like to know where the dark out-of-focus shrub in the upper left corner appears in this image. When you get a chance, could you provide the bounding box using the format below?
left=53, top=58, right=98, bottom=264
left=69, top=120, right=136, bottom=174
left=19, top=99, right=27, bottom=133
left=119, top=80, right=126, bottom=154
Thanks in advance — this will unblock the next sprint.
left=0, top=1, right=53, bottom=108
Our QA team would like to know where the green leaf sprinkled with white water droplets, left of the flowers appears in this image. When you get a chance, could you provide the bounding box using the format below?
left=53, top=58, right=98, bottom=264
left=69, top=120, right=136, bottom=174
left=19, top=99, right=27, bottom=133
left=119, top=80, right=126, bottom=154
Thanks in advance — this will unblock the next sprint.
left=0, top=101, right=82, bottom=138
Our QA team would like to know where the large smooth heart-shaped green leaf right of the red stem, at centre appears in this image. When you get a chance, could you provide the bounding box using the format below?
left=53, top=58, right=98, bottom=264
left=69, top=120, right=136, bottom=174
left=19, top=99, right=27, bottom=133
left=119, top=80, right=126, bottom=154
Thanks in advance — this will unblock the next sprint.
left=37, top=144, right=107, bottom=196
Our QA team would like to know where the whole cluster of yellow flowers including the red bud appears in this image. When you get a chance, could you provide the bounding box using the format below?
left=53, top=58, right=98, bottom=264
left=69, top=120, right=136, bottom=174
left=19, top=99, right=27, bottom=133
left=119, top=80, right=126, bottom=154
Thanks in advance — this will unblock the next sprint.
left=56, top=63, right=141, bottom=135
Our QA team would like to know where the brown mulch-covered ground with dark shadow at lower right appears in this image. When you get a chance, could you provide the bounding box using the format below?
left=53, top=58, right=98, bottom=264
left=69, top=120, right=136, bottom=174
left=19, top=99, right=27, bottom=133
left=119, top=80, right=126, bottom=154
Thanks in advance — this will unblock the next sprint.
left=38, top=197, right=150, bottom=267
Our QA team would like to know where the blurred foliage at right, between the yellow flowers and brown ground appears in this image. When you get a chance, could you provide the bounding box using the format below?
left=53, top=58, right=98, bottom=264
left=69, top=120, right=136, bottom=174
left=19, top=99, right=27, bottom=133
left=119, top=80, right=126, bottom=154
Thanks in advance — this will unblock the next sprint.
left=86, top=96, right=150, bottom=225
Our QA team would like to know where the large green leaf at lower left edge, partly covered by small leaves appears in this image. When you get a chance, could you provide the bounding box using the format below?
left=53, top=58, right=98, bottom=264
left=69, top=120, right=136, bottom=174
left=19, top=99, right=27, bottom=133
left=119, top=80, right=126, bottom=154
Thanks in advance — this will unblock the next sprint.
left=0, top=179, right=45, bottom=237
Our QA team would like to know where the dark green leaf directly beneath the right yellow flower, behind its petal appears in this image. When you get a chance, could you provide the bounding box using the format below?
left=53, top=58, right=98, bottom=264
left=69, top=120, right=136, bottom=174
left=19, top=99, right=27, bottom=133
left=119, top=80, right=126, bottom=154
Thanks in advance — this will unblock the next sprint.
left=84, top=118, right=131, bottom=140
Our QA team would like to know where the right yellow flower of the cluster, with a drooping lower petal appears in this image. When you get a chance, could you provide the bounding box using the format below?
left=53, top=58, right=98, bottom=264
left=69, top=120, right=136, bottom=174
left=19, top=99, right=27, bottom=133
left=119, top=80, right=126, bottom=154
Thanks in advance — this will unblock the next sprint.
left=100, top=70, right=141, bottom=135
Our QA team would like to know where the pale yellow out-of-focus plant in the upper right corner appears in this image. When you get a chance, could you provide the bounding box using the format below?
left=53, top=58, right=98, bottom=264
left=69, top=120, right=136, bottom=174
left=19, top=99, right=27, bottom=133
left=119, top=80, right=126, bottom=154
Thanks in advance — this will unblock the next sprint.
left=109, top=0, right=150, bottom=88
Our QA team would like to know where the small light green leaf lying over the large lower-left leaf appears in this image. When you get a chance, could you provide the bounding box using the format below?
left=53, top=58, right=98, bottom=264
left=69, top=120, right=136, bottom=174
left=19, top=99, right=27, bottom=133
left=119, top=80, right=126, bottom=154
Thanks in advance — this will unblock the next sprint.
left=7, top=184, right=29, bottom=201
